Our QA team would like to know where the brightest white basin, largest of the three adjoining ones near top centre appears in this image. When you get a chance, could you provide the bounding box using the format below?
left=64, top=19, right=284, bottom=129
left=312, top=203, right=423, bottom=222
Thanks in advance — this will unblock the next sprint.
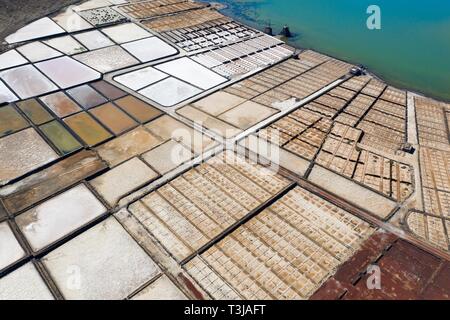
left=156, top=57, right=228, bottom=90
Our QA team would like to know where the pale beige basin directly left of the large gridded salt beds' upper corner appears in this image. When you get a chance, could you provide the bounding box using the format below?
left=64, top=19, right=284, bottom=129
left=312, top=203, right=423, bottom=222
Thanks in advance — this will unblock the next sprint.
left=90, top=158, right=158, bottom=207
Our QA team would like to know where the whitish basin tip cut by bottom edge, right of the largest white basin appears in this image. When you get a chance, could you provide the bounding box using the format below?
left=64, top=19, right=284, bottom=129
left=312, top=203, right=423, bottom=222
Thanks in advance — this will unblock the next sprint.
left=132, top=275, right=187, bottom=300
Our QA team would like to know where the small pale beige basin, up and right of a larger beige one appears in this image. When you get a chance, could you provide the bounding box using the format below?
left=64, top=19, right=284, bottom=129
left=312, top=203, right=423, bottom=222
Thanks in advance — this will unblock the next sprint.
left=142, top=140, right=193, bottom=175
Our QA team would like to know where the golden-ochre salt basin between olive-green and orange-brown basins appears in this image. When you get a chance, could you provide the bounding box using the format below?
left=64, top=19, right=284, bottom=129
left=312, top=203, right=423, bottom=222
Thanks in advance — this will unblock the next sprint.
left=64, top=112, right=112, bottom=146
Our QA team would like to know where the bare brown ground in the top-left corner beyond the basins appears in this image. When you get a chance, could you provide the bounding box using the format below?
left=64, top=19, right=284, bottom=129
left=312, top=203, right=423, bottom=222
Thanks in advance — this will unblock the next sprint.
left=0, top=0, right=80, bottom=52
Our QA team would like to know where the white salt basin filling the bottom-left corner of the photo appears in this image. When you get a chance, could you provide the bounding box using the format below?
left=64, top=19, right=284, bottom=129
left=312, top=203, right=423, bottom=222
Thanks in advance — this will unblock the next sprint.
left=0, top=262, right=54, bottom=300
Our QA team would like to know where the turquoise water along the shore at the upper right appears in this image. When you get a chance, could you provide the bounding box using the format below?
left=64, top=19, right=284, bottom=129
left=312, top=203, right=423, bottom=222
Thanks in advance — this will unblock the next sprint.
left=210, top=0, right=450, bottom=101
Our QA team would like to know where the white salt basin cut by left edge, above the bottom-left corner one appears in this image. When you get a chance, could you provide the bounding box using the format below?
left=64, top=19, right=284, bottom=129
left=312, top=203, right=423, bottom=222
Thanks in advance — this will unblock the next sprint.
left=0, top=221, right=25, bottom=270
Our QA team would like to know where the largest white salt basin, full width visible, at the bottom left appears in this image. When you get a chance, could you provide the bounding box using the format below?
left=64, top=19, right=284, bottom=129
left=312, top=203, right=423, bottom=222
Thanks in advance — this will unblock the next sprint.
left=42, top=217, right=160, bottom=300
